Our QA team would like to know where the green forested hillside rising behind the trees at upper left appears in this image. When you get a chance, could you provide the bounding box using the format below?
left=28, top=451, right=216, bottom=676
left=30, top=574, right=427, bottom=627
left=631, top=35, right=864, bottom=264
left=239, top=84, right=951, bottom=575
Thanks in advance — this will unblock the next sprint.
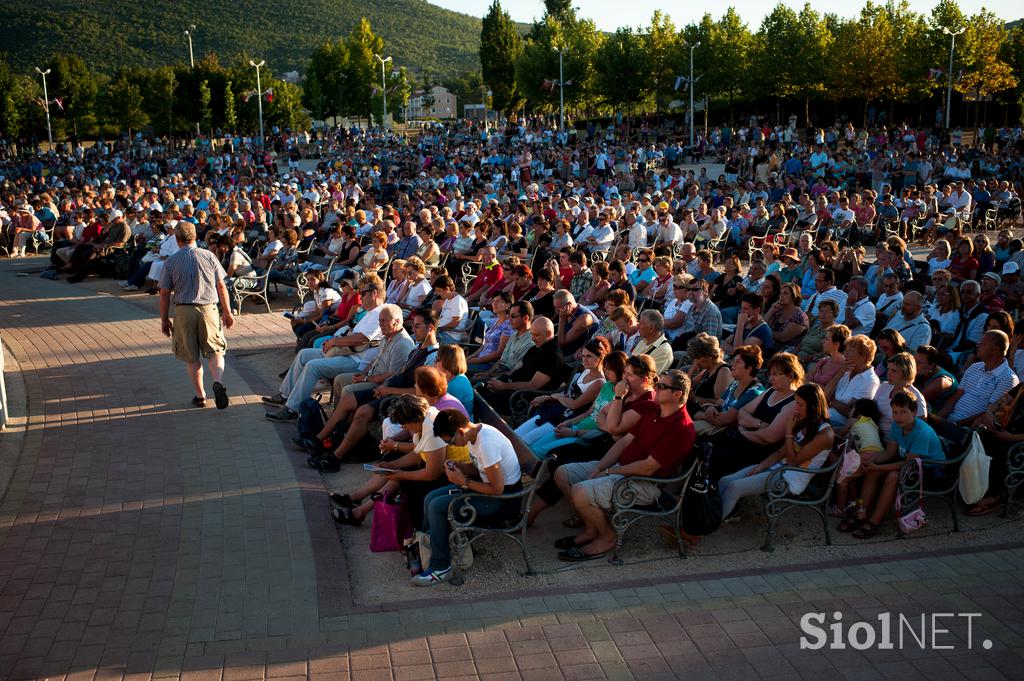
left=0, top=0, right=480, bottom=76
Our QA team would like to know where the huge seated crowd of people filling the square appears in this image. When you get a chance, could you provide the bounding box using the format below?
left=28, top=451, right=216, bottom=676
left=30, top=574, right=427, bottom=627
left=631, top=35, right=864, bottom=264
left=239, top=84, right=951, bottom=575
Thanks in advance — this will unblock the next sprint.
left=0, top=114, right=1024, bottom=586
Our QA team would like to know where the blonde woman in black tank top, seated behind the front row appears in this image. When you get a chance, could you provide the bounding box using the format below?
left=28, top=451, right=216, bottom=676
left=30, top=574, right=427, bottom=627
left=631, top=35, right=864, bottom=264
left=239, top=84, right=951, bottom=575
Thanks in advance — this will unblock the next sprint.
left=711, top=352, right=804, bottom=480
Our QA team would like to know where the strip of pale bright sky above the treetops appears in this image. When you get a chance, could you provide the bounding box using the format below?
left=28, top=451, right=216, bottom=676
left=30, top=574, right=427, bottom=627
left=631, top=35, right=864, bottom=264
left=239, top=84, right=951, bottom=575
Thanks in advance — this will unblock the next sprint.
left=429, top=0, right=1024, bottom=31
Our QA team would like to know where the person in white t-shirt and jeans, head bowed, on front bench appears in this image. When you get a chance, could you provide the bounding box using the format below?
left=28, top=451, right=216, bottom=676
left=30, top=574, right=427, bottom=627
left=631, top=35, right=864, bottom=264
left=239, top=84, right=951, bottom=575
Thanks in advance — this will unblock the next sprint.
left=412, top=409, right=522, bottom=587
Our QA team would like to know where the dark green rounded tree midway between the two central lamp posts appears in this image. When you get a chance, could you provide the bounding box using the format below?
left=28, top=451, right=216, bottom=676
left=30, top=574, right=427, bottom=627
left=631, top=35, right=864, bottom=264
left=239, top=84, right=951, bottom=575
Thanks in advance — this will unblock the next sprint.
left=595, top=28, right=653, bottom=114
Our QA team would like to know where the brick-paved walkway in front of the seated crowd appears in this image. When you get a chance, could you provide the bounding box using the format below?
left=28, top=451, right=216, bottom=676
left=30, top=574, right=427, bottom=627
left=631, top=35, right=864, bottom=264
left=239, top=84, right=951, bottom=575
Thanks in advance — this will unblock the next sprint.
left=0, top=262, right=1024, bottom=681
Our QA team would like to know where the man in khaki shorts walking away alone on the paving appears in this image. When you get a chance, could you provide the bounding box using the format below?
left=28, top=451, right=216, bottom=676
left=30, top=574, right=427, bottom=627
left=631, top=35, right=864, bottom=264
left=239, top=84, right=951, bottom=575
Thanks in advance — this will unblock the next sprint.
left=160, top=220, right=234, bottom=409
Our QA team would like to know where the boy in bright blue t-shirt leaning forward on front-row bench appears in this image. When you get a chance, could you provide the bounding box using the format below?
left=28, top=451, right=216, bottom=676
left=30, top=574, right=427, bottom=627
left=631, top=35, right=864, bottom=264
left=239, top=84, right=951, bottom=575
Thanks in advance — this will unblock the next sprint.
left=853, top=392, right=946, bottom=539
